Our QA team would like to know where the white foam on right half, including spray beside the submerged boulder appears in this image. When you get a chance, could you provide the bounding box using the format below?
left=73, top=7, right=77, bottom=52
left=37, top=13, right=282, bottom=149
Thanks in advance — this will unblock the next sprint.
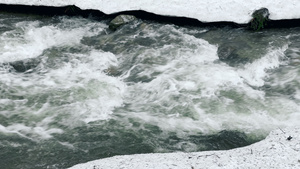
left=119, top=26, right=299, bottom=135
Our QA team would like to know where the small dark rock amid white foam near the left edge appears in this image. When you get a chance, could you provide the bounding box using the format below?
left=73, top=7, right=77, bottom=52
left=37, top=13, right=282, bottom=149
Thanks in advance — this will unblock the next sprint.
left=9, top=58, right=41, bottom=72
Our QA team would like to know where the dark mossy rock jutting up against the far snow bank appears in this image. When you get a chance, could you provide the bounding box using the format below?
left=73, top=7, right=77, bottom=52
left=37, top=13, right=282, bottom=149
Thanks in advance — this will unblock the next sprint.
left=249, top=8, right=270, bottom=31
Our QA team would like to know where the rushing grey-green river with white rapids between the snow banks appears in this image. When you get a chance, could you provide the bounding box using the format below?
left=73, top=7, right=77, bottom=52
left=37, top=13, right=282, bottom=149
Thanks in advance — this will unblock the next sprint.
left=0, top=11, right=300, bottom=169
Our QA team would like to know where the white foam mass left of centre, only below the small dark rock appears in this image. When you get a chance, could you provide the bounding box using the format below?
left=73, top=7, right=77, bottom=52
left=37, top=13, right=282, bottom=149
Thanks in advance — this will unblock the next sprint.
left=1, top=51, right=125, bottom=138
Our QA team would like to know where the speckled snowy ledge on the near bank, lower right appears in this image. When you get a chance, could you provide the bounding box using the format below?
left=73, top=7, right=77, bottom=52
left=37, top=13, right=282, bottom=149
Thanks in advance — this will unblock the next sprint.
left=70, top=127, right=300, bottom=169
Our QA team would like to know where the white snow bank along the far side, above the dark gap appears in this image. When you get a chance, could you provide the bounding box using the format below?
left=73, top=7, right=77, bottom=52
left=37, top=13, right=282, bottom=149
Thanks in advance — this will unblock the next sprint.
left=0, top=0, right=300, bottom=24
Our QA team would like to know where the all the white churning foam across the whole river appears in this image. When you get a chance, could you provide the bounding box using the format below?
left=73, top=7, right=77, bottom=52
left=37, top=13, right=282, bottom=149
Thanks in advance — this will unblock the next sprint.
left=1, top=18, right=298, bottom=141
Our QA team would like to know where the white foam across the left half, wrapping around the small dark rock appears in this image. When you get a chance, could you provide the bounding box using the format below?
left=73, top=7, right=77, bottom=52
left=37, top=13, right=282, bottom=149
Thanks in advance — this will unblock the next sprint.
left=0, top=18, right=125, bottom=139
